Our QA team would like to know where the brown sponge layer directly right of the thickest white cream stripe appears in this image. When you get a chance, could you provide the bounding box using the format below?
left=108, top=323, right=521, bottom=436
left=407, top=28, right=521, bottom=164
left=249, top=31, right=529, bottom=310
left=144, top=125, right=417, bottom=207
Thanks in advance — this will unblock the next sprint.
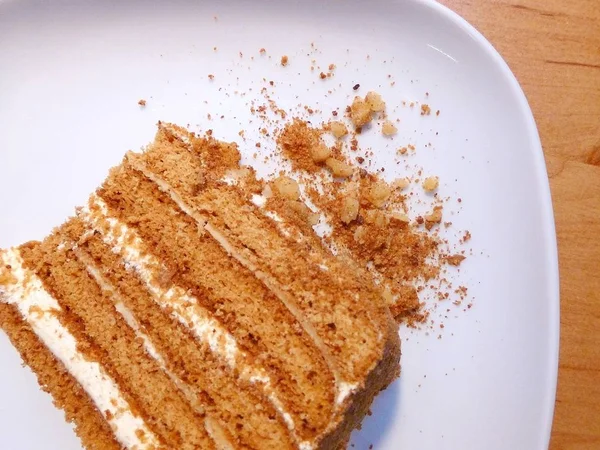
left=21, top=241, right=218, bottom=449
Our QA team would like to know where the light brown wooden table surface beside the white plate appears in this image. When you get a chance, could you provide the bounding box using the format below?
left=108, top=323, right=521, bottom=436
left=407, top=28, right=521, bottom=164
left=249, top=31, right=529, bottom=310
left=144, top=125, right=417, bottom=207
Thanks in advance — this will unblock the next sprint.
left=440, top=0, right=600, bottom=450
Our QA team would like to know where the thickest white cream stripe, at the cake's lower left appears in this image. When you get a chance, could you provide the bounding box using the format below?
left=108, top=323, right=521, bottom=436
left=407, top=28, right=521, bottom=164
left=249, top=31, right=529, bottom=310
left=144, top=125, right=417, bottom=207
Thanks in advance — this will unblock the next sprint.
left=0, top=249, right=159, bottom=450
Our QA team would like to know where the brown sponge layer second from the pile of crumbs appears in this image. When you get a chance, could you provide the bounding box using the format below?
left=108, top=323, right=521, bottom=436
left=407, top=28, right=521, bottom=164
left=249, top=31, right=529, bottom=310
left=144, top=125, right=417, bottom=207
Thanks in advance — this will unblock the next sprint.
left=96, top=162, right=334, bottom=441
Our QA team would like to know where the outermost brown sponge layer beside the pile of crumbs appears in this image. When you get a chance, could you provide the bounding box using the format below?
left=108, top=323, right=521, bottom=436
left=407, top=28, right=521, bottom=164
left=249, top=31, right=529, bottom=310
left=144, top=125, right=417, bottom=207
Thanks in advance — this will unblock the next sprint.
left=129, top=127, right=398, bottom=390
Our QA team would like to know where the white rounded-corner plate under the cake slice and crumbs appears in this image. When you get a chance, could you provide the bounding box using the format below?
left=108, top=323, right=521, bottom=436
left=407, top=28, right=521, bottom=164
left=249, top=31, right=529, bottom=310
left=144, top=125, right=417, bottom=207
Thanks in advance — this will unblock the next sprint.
left=0, top=0, right=559, bottom=450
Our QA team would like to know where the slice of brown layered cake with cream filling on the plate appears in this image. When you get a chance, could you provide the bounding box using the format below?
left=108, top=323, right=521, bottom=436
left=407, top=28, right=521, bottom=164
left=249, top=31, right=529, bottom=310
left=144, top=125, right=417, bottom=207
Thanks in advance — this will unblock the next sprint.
left=0, top=125, right=400, bottom=450
